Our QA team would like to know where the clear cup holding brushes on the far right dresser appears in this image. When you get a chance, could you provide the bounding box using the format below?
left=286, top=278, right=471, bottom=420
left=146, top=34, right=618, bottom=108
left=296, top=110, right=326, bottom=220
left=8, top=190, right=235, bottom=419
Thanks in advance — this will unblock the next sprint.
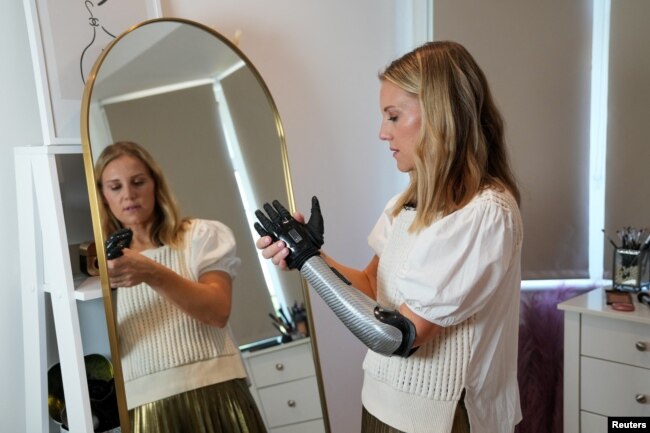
left=612, top=248, right=650, bottom=291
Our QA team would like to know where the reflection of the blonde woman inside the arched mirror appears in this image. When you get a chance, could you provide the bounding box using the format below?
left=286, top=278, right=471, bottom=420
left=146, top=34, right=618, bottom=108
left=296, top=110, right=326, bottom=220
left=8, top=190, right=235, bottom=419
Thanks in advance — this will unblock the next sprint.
left=95, top=142, right=266, bottom=433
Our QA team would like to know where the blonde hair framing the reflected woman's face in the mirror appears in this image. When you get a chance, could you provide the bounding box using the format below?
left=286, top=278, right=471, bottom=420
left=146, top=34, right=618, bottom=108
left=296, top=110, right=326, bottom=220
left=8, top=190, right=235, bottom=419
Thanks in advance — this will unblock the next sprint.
left=95, top=141, right=189, bottom=247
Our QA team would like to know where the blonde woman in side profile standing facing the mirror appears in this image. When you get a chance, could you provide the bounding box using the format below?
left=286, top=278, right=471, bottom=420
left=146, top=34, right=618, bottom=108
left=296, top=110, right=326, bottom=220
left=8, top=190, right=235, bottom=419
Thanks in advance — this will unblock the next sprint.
left=257, top=42, right=523, bottom=433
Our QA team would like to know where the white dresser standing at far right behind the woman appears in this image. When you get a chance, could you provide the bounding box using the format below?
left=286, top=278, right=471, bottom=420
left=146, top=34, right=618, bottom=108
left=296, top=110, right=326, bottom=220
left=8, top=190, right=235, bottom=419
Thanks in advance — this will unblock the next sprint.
left=558, top=289, right=650, bottom=433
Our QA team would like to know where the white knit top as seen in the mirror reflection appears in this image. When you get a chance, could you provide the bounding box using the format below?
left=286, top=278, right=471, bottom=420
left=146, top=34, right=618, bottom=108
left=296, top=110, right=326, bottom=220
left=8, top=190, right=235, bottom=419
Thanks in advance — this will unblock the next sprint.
left=117, top=220, right=246, bottom=409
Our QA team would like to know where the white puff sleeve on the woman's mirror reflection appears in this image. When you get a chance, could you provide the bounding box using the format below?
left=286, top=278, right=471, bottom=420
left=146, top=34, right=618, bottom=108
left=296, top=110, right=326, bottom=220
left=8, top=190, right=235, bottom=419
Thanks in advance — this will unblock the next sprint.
left=188, top=219, right=241, bottom=279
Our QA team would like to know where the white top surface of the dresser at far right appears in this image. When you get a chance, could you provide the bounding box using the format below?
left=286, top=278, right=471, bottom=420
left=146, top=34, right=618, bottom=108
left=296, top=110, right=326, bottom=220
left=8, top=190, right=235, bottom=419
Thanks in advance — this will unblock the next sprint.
left=557, top=287, right=650, bottom=325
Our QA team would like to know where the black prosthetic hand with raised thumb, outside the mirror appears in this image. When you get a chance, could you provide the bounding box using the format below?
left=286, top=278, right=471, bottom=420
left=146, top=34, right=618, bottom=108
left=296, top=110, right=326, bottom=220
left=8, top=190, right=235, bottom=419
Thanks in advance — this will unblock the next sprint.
left=254, top=197, right=324, bottom=269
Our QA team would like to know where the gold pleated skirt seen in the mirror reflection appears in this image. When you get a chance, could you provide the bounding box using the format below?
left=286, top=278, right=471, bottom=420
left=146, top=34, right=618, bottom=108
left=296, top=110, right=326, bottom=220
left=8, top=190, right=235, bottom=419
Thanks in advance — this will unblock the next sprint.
left=129, top=379, right=266, bottom=433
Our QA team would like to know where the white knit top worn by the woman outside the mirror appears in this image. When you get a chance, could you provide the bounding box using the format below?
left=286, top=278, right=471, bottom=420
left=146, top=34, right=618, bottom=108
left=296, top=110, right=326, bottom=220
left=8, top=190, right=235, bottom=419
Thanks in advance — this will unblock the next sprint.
left=362, top=190, right=522, bottom=433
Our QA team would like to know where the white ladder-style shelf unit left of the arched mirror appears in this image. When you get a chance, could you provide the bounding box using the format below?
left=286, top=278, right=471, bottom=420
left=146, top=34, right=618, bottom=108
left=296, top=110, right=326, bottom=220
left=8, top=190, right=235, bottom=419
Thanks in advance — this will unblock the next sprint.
left=14, top=145, right=109, bottom=433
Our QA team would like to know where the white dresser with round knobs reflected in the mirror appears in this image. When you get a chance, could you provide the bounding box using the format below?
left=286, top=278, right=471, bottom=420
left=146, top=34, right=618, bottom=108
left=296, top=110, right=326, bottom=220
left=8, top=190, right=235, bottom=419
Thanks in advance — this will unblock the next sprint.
left=242, top=338, right=325, bottom=433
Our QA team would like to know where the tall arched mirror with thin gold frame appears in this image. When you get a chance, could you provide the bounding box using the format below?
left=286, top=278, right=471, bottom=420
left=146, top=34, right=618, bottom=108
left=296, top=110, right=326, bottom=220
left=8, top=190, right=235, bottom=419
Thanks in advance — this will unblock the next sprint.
left=82, top=20, right=325, bottom=432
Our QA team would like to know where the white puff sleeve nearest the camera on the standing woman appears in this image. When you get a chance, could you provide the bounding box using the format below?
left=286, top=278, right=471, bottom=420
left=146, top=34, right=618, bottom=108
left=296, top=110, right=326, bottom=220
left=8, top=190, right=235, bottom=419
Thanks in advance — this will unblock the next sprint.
left=396, top=195, right=519, bottom=326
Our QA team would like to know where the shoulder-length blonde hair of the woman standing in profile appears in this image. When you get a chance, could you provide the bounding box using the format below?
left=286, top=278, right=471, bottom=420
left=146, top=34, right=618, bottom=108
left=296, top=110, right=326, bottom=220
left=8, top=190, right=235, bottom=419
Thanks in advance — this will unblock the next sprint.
left=379, top=41, right=520, bottom=232
